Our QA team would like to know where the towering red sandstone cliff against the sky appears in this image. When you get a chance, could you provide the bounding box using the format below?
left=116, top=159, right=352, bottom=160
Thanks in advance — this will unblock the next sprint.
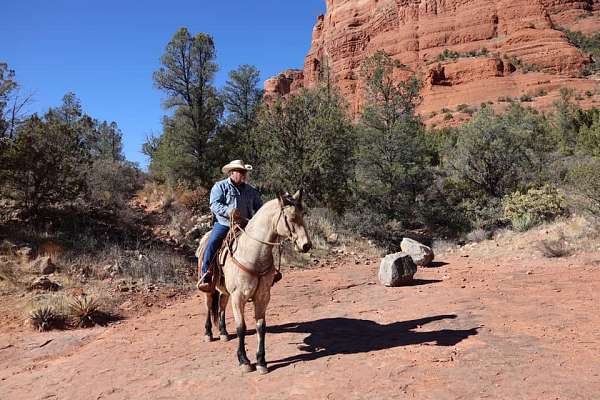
left=265, top=0, right=600, bottom=122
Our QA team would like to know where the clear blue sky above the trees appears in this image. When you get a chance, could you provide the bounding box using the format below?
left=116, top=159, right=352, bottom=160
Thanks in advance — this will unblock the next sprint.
left=0, top=0, right=325, bottom=166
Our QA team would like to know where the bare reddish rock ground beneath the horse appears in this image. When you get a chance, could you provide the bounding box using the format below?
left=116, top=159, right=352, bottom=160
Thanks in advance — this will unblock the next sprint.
left=0, top=233, right=600, bottom=400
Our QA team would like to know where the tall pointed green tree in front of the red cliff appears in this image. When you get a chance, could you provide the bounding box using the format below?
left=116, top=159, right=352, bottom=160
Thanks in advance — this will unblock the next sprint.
left=357, top=52, right=433, bottom=225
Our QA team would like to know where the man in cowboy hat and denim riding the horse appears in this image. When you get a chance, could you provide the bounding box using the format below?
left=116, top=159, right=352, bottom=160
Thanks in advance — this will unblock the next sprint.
left=198, top=160, right=262, bottom=291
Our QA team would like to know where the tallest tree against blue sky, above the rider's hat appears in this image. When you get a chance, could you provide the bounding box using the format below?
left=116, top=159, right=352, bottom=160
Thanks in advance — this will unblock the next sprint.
left=149, top=28, right=223, bottom=185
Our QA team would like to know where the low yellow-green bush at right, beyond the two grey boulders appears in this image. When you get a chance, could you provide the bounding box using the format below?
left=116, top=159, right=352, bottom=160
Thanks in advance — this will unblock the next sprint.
left=502, top=185, right=567, bottom=231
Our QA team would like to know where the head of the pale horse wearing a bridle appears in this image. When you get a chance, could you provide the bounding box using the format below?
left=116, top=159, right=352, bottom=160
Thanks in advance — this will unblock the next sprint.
left=276, top=189, right=312, bottom=253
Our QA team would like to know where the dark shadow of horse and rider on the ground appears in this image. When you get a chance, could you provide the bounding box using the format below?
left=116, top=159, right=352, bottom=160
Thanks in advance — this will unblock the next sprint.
left=267, top=314, right=479, bottom=370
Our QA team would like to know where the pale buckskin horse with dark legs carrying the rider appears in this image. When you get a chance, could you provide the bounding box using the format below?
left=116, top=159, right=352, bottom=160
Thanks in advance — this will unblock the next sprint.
left=196, top=190, right=312, bottom=374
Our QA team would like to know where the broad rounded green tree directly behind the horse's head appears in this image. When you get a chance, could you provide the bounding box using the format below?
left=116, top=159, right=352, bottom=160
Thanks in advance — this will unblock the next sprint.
left=253, top=87, right=355, bottom=211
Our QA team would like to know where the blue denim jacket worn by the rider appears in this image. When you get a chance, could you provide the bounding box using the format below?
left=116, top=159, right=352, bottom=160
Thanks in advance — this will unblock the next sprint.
left=210, top=178, right=262, bottom=226
